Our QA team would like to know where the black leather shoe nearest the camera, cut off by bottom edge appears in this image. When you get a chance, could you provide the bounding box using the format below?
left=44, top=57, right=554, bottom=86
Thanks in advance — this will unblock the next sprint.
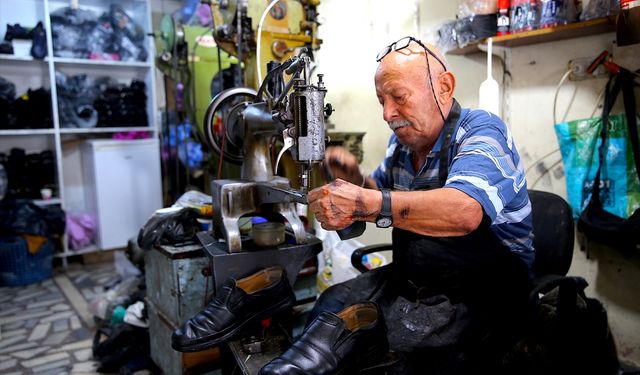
left=259, top=302, right=389, bottom=375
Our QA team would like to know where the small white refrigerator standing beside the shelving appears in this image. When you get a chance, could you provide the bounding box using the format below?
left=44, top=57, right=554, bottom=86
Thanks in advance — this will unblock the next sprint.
left=82, top=139, right=162, bottom=250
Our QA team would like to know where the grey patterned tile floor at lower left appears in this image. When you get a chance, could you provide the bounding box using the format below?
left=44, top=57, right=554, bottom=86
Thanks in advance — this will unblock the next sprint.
left=0, top=263, right=117, bottom=375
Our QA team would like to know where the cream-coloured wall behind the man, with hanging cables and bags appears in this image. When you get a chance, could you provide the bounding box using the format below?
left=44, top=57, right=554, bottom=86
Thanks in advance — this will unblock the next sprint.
left=318, top=0, right=640, bottom=364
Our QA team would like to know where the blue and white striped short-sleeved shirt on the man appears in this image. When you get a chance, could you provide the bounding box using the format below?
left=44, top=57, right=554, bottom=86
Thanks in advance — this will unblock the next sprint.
left=371, top=108, right=535, bottom=269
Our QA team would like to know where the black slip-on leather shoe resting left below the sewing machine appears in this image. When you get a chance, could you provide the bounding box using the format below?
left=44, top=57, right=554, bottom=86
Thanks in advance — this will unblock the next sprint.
left=171, top=266, right=295, bottom=352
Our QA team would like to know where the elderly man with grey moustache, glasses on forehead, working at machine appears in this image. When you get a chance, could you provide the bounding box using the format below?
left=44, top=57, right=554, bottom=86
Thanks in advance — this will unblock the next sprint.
left=263, top=37, right=534, bottom=374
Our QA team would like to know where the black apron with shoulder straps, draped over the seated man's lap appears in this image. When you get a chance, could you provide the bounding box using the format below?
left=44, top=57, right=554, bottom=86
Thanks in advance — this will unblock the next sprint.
left=308, top=100, right=529, bottom=375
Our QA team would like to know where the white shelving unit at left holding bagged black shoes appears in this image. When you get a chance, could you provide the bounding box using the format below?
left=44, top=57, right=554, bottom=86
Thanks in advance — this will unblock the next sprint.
left=0, top=0, right=161, bottom=264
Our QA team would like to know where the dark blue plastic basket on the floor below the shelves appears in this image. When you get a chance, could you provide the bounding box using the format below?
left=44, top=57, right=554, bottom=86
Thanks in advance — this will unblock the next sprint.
left=0, top=236, right=53, bottom=286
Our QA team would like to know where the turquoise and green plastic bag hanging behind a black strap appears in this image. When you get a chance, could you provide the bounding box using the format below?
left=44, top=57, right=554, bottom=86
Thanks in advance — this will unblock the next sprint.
left=555, top=114, right=640, bottom=219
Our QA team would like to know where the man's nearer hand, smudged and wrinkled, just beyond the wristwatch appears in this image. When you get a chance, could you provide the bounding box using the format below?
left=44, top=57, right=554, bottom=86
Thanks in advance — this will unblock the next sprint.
left=307, top=179, right=382, bottom=230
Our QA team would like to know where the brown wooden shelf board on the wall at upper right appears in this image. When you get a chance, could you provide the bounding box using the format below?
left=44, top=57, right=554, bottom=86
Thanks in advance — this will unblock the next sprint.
left=447, top=17, right=615, bottom=55
